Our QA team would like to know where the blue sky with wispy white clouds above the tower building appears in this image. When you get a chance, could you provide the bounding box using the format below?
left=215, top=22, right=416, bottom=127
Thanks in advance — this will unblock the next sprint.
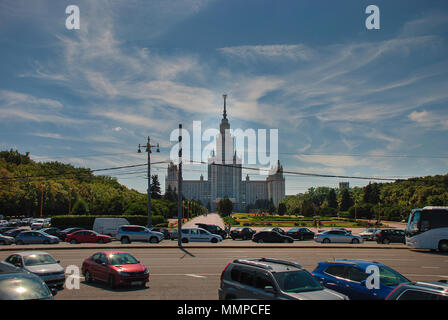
left=0, top=0, right=448, bottom=194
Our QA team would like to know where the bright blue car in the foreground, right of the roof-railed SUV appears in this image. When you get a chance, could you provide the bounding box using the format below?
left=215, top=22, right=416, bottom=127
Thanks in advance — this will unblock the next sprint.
left=312, top=260, right=410, bottom=300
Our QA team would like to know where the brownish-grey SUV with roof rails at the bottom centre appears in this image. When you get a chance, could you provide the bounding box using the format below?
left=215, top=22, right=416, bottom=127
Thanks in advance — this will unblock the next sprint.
left=218, top=258, right=347, bottom=300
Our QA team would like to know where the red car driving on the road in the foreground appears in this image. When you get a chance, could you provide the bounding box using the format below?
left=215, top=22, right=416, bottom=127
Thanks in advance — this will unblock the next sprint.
left=82, top=251, right=149, bottom=288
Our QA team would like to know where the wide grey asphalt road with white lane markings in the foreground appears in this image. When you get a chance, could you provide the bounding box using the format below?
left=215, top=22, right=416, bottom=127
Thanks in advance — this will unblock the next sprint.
left=0, top=247, right=448, bottom=300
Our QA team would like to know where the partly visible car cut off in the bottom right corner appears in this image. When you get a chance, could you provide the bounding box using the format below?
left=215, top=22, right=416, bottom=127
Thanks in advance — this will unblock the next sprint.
left=386, top=281, right=448, bottom=301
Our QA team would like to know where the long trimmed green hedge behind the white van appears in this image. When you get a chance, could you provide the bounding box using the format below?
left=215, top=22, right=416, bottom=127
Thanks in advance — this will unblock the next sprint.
left=51, top=215, right=166, bottom=230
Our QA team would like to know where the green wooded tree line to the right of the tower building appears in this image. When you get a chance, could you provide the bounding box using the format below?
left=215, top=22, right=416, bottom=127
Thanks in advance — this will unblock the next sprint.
left=277, top=174, right=448, bottom=221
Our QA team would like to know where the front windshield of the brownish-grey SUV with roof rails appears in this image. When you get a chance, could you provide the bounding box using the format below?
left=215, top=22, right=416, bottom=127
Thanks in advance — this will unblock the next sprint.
left=273, top=270, right=323, bottom=293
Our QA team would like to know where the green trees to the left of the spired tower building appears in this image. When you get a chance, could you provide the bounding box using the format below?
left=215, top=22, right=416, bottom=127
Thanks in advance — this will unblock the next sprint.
left=0, top=150, right=205, bottom=218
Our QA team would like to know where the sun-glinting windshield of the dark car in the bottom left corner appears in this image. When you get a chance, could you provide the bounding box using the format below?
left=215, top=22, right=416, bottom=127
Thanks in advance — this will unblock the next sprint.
left=0, top=277, right=51, bottom=300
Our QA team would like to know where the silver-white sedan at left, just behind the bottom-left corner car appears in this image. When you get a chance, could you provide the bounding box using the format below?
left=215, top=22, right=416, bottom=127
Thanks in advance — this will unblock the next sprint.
left=3, top=251, right=65, bottom=289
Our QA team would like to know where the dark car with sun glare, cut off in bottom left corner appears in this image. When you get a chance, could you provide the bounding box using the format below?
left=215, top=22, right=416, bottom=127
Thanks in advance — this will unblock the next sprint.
left=0, top=263, right=57, bottom=300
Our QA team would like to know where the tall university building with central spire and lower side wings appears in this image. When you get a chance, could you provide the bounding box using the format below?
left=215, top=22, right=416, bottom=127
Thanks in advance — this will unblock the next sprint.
left=165, top=95, right=285, bottom=211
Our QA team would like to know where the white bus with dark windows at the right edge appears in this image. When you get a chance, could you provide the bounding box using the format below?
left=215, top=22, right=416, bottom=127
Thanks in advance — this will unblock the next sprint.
left=405, top=207, right=448, bottom=252
